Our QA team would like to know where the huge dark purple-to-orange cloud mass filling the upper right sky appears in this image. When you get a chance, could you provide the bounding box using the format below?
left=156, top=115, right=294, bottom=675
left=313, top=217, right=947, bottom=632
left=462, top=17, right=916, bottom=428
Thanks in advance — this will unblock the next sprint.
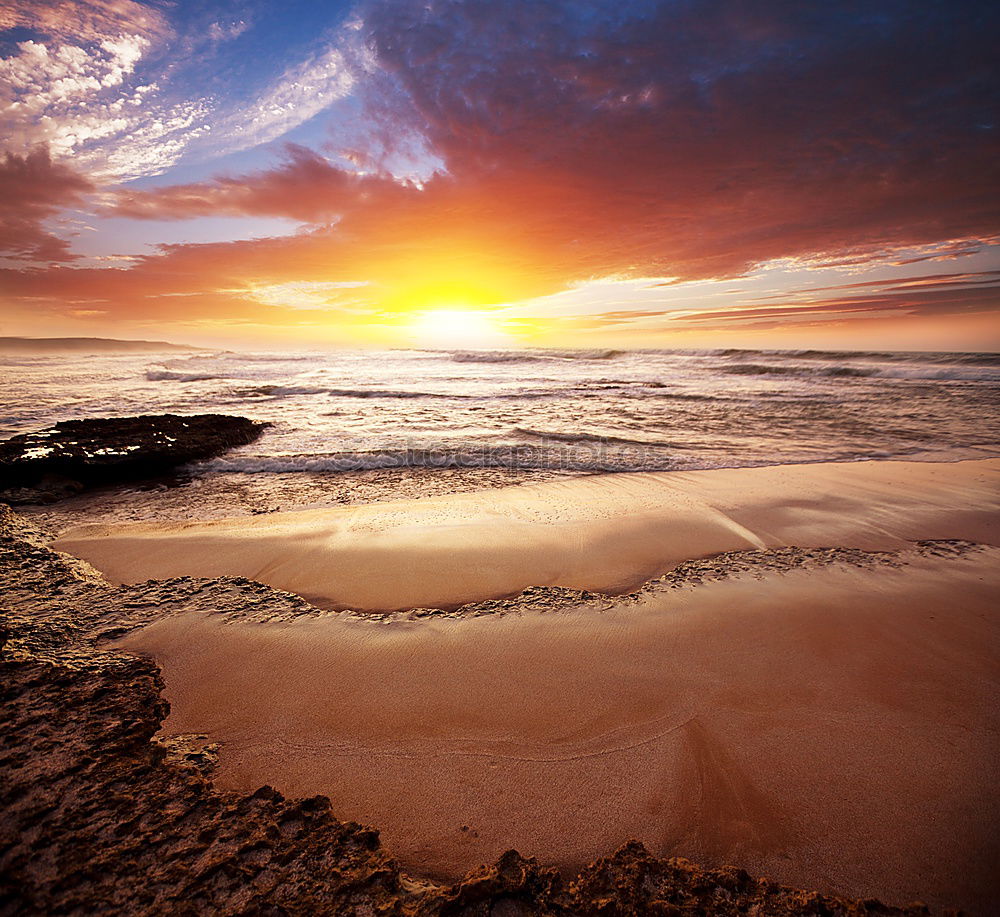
left=97, top=0, right=1000, bottom=280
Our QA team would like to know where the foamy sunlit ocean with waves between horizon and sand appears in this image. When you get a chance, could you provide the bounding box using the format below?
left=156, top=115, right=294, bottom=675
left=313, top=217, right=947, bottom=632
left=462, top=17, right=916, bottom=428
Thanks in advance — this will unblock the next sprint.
left=0, top=350, right=1000, bottom=474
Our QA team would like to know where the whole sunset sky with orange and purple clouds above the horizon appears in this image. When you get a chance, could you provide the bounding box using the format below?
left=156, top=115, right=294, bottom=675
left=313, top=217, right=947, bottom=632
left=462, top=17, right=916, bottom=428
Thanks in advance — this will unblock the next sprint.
left=0, top=0, right=1000, bottom=350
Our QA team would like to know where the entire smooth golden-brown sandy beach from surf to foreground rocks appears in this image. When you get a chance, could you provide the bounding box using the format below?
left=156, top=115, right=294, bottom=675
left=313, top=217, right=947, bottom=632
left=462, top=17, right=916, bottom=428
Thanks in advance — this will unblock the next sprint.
left=43, top=460, right=1000, bottom=913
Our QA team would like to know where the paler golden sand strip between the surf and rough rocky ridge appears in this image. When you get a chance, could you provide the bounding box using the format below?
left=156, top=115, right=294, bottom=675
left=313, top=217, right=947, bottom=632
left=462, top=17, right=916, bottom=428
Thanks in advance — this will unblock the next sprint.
left=53, top=459, right=1000, bottom=611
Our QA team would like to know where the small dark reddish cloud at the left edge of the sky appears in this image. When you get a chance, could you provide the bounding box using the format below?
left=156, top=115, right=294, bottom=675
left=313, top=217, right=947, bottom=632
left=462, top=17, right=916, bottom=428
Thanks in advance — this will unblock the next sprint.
left=0, top=147, right=93, bottom=261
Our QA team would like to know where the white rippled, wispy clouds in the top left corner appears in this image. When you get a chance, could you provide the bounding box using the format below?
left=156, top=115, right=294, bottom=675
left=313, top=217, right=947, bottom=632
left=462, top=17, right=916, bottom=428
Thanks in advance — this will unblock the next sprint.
left=0, top=0, right=364, bottom=181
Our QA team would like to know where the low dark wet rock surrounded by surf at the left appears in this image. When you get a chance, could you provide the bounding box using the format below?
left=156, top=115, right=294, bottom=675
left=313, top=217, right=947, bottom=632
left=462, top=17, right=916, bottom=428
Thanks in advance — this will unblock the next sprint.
left=0, top=414, right=267, bottom=503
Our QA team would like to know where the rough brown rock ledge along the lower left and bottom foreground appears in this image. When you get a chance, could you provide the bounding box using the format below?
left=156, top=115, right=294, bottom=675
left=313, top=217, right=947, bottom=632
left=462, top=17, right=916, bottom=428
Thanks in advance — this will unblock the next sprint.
left=0, top=506, right=944, bottom=917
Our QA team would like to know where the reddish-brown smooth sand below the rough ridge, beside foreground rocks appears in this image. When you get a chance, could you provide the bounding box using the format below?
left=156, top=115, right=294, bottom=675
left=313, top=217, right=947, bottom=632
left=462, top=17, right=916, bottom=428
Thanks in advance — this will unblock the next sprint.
left=119, top=549, right=1000, bottom=914
